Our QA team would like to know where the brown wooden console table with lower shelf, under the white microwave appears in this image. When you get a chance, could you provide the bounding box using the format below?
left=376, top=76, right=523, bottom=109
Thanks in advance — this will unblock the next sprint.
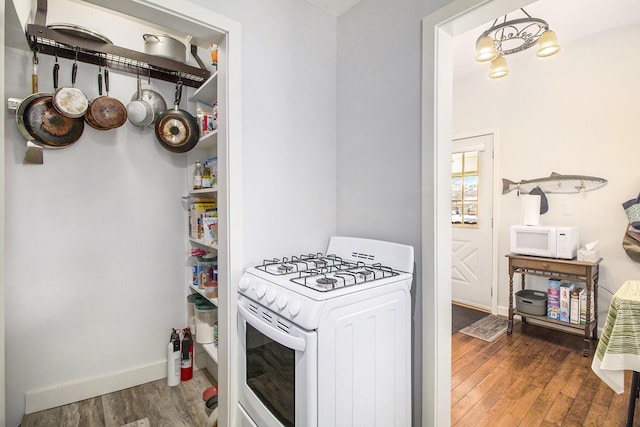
left=506, top=254, right=602, bottom=357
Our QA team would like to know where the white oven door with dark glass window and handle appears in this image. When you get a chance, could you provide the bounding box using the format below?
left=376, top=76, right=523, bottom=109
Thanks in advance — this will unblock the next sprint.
left=238, top=295, right=318, bottom=427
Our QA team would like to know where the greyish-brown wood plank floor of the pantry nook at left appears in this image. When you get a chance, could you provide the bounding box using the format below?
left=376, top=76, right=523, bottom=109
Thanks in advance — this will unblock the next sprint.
left=21, top=369, right=215, bottom=427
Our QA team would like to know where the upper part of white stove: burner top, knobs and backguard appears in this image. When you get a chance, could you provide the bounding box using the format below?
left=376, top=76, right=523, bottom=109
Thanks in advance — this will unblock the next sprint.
left=238, top=236, right=413, bottom=329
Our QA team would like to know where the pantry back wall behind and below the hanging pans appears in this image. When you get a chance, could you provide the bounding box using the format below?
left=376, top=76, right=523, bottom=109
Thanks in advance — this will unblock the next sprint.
left=5, top=49, right=186, bottom=425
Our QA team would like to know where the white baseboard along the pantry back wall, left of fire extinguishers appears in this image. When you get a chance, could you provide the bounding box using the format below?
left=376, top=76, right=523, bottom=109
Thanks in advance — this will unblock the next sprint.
left=25, top=361, right=167, bottom=414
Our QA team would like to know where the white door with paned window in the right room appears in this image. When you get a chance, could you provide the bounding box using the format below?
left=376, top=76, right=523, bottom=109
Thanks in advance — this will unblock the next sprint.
left=451, top=134, right=493, bottom=311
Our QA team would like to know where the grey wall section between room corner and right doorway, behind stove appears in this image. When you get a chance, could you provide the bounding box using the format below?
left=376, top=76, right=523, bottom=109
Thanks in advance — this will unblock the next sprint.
left=337, top=0, right=446, bottom=426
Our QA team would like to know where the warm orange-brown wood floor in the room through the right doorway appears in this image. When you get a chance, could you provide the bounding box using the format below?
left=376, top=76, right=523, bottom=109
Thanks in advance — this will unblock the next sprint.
left=451, top=323, right=640, bottom=427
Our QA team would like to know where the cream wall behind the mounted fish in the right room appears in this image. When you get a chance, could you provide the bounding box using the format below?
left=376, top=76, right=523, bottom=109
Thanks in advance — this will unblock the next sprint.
left=453, top=26, right=640, bottom=320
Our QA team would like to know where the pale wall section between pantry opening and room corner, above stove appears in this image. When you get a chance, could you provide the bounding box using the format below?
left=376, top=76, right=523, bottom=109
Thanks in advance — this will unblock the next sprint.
left=195, top=0, right=336, bottom=267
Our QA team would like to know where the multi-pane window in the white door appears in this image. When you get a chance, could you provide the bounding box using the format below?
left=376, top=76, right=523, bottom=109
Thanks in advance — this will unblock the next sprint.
left=451, top=151, right=478, bottom=226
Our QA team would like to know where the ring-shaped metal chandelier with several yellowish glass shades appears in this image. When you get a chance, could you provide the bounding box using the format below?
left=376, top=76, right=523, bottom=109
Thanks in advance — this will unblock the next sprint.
left=476, top=8, right=560, bottom=79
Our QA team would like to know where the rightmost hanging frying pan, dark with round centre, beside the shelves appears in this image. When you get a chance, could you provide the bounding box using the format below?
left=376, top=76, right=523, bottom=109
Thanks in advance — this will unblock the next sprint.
left=155, top=82, right=200, bottom=153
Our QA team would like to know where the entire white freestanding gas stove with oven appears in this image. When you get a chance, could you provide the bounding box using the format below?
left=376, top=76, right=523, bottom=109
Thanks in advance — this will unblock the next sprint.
left=238, top=236, right=414, bottom=427
